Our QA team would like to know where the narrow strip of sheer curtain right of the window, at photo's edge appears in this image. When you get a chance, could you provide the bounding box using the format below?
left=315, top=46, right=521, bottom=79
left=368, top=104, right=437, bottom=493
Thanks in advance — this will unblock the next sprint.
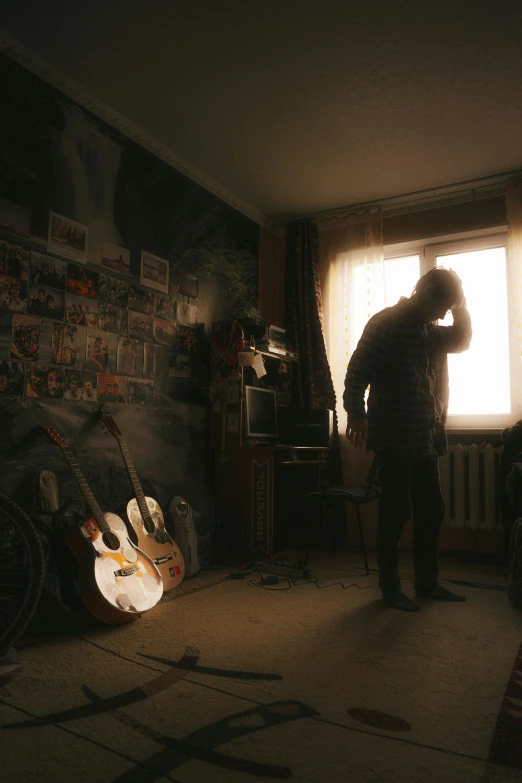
left=506, top=180, right=522, bottom=374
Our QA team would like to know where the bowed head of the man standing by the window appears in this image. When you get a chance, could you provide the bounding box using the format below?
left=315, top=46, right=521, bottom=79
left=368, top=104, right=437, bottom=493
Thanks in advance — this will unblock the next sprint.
left=410, top=267, right=464, bottom=323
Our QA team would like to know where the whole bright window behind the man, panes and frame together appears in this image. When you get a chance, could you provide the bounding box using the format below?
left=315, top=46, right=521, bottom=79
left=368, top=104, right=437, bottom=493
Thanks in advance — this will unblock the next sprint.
left=380, top=229, right=522, bottom=430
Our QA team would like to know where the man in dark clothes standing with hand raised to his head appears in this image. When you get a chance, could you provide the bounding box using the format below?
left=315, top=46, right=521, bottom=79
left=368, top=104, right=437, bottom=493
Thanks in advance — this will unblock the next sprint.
left=343, top=268, right=472, bottom=612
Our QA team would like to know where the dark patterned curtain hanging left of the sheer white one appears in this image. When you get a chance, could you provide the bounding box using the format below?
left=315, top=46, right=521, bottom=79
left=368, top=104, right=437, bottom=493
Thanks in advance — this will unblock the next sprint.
left=285, top=219, right=342, bottom=484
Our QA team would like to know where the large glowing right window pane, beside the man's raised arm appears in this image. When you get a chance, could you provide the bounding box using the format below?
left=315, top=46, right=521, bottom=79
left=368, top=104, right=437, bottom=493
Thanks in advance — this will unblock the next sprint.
left=436, top=247, right=511, bottom=415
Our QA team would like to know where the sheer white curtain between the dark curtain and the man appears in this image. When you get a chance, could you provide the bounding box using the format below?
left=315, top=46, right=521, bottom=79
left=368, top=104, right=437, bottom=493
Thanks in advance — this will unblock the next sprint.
left=318, top=210, right=386, bottom=436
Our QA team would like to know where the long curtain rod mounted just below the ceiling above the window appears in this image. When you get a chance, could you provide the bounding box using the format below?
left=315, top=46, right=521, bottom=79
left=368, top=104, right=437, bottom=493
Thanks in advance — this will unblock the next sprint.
left=303, top=169, right=522, bottom=222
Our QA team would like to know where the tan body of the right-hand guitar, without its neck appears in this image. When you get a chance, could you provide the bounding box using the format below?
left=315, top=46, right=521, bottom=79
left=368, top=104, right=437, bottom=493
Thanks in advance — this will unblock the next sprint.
left=127, top=497, right=185, bottom=590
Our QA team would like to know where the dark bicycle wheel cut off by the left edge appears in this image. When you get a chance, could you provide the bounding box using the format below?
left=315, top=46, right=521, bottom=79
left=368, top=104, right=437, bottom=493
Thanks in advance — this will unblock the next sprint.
left=0, top=493, right=46, bottom=658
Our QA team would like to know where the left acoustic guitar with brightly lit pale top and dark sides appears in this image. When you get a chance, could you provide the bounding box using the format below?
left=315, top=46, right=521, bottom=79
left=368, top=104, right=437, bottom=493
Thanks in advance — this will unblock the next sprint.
left=42, top=427, right=163, bottom=625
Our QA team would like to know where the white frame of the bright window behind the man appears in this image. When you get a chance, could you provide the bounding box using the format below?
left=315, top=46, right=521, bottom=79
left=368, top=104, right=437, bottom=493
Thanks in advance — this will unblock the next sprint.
left=384, top=225, right=522, bottom=435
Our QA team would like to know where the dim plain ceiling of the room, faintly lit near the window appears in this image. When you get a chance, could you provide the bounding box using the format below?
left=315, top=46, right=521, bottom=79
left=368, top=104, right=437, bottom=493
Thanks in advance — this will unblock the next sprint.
left=0, top=0, right=522, bottom=222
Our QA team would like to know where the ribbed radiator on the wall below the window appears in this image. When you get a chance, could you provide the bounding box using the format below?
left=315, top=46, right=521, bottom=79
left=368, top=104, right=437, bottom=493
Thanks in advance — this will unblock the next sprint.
left=439, top=443, right=503, bottom=530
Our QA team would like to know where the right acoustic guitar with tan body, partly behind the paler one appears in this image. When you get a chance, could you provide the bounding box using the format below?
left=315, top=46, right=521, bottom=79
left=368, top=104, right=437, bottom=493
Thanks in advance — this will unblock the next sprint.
left=100, top=408, right=185, bottom=590
